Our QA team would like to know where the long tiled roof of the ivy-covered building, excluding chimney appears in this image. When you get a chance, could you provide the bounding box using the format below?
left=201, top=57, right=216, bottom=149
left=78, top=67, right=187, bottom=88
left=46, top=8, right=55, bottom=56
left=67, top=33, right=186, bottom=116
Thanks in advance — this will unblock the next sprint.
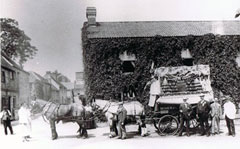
left=87, top=21, right=240, bottom=38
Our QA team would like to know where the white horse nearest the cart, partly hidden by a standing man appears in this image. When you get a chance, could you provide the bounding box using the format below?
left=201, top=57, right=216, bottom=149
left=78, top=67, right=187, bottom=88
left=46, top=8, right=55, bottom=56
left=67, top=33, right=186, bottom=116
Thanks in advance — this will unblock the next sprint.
left=95, top=100, right=147, bottom=138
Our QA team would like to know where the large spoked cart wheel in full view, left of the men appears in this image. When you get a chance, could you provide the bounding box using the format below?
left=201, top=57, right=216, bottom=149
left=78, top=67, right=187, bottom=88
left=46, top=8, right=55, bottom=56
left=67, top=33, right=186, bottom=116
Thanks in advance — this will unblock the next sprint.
left=158, top=115, right=179, bottom=135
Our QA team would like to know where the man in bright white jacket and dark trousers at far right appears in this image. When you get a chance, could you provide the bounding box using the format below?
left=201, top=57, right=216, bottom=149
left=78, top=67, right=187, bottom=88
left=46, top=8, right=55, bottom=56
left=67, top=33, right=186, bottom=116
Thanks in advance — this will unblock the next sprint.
left=223, top=97, right=236, bottom=137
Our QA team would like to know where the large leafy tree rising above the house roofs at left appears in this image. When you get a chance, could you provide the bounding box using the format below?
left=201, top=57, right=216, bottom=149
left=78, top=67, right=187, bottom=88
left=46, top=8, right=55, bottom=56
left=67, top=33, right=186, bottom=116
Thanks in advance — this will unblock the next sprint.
left=0, top=18, right=37, bottom=65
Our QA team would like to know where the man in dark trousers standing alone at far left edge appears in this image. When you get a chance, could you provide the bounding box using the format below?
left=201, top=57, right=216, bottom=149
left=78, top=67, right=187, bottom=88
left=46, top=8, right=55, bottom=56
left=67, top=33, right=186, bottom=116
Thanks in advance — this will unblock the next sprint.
left=0, top=106, right=13, bottom=135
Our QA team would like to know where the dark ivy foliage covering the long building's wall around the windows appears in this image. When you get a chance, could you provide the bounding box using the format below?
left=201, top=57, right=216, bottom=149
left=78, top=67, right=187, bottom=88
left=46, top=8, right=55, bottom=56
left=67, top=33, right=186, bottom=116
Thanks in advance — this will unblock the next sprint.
left=82, top=26, right=240, bottom=101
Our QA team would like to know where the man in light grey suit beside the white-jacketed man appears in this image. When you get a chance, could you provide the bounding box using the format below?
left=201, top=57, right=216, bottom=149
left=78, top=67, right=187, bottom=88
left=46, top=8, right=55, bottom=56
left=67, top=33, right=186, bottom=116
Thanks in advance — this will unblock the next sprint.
left=211, top=98, right=222, bottom=135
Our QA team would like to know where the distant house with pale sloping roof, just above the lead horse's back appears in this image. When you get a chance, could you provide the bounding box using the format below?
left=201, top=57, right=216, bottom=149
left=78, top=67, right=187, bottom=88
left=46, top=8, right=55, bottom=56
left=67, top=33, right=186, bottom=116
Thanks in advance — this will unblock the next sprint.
left=44, top=72, right=67, bottom=103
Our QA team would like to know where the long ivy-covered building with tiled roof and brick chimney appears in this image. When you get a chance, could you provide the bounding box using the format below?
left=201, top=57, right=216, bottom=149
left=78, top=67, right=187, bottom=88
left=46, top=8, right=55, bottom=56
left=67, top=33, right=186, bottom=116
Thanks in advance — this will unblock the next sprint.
left=82, top=7, right=240, bottom=101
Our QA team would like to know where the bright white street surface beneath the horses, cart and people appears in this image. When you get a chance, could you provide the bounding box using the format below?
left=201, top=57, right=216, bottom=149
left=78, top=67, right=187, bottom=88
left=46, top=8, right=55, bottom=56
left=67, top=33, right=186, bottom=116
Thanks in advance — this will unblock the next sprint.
left=0, top=117, right=240, bottom=149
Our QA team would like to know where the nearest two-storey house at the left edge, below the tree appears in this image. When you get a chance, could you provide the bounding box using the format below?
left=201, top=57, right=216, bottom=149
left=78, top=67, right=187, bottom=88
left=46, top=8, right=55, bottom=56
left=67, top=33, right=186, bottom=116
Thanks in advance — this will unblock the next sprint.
left=0, top=52, right=30, bottom=118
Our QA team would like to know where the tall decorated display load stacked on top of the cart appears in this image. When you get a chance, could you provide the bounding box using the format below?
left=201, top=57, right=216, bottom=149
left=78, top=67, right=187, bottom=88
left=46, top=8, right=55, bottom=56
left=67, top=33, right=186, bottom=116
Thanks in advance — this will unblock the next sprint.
left=155, top=65, right=213, bottom=104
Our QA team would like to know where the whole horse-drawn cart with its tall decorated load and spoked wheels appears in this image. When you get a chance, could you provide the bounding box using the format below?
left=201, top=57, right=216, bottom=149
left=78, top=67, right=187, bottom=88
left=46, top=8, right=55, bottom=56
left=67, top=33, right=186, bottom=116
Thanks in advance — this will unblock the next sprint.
left=149, top=65, right=213, bottom=135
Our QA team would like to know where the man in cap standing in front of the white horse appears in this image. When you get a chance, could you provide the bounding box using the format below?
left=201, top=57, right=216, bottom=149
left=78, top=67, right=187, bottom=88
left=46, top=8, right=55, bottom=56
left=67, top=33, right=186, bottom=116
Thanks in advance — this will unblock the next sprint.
left=117, top=102, right=127, bottom=139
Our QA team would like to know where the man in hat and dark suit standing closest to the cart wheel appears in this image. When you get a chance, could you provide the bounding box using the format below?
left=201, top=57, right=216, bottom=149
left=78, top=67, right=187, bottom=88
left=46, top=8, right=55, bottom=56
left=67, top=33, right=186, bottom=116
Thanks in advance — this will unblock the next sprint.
left=179, top=98, right=192, bottom=136
